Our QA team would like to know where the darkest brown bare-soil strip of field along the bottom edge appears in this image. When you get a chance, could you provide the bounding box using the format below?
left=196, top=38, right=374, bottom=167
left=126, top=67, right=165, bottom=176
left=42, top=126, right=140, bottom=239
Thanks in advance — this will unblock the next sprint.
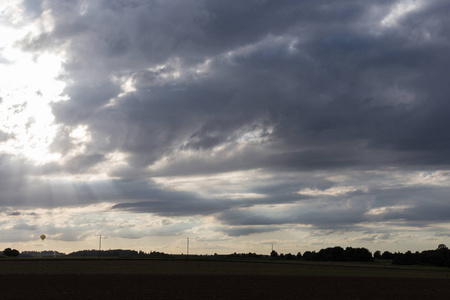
left=0, top=274, right=450, bottom=299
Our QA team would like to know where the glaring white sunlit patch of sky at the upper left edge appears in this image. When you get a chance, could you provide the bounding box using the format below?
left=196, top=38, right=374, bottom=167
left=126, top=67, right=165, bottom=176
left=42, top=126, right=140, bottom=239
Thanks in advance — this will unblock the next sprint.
left=0, top=1, right=65, bottom=163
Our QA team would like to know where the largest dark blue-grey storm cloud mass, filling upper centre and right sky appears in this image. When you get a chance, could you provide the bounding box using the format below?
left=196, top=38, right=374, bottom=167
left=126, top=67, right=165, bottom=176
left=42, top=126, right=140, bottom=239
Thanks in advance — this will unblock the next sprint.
left=43, top=2, right=450, bottom=174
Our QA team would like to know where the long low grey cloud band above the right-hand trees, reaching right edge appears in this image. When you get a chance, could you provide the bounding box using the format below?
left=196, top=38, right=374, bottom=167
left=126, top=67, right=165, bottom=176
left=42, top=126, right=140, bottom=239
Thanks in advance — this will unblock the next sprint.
left=217, top=186, right=450, bottom=231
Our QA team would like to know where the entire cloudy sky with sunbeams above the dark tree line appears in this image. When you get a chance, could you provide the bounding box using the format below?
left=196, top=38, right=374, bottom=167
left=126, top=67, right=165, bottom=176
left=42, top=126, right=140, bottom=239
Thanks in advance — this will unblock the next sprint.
left=0, top=0, right=450, bottom=254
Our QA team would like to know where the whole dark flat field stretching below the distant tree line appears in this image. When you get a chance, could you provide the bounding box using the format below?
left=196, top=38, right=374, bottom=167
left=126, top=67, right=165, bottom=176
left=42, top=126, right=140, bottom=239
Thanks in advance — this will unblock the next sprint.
left=0, top=259, right=450, bottom=299
